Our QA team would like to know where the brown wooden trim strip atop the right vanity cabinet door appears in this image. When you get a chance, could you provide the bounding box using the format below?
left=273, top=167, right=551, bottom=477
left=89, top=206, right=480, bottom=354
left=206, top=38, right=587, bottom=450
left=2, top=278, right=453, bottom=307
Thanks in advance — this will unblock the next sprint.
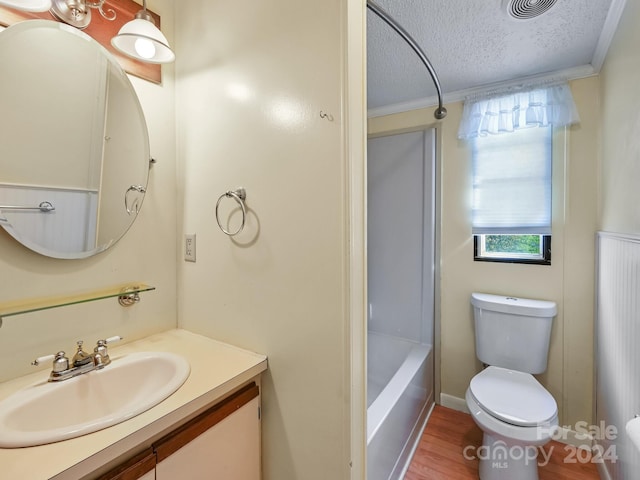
left=153, top=382, right=260, bottom=463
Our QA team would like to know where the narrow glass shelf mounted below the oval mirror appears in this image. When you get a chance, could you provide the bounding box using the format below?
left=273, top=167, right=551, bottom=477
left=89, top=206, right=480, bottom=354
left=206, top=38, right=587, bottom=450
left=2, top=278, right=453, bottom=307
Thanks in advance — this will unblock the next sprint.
left=0, top=283, right=156, bottom=318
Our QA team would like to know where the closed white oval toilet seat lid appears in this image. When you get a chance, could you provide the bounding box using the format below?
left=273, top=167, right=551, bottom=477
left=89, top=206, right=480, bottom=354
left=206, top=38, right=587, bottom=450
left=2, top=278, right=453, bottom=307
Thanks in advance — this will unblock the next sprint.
left=469, top=366, right=558, bottom=427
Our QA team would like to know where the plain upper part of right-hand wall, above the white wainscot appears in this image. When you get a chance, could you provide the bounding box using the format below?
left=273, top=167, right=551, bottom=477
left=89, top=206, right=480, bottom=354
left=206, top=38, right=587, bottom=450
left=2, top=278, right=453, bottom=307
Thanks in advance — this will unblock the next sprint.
left=600, top=2, right=640, bottom=234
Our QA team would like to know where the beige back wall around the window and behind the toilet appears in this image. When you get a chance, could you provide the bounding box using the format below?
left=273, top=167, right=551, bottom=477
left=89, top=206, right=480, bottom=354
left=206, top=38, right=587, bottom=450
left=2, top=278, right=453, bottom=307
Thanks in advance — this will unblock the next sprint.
left=369, top=77, right=599, bottom=426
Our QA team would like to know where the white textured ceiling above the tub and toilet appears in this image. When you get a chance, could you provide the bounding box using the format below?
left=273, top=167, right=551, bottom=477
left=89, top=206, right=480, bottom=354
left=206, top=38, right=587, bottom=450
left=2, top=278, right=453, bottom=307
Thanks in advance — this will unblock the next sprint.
left=367, top=0, right=626, bottom=113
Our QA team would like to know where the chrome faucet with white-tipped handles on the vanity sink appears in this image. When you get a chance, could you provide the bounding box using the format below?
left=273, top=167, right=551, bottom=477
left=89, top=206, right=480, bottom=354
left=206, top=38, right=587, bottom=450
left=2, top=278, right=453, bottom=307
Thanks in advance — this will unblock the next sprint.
left=31, top=335, right=122, bottom=382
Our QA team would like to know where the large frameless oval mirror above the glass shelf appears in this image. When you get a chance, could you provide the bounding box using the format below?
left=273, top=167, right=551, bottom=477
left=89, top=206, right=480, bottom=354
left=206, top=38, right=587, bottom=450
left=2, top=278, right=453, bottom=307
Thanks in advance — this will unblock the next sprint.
left=0, top=20, right=149, bottom=258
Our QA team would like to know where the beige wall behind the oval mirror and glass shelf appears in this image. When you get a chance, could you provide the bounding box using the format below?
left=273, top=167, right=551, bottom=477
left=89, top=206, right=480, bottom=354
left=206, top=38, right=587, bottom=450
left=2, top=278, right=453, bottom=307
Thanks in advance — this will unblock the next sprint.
left=0, top=0, right=177, bottom=380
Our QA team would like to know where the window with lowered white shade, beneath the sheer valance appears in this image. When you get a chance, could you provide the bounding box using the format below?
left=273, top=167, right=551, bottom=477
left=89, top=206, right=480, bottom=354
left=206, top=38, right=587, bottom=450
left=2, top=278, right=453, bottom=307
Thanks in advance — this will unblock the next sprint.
left=472, top=127, right=552, bottom=265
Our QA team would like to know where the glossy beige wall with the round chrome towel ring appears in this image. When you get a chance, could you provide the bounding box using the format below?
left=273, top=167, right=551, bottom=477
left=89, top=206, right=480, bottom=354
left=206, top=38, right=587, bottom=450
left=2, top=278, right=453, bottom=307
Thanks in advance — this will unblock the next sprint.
left=176, top=0, right=364, bottom=480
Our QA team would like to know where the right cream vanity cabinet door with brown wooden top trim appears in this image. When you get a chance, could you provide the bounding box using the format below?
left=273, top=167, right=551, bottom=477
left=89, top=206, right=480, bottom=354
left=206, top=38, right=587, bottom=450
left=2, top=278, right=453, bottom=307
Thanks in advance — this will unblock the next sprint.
left=155, top=384, right=261, bottom=480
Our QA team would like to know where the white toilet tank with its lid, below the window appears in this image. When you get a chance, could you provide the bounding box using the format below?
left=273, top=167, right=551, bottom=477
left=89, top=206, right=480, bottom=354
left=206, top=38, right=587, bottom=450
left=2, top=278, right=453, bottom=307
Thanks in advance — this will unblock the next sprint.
left=471, top=293, right=557, bottom=374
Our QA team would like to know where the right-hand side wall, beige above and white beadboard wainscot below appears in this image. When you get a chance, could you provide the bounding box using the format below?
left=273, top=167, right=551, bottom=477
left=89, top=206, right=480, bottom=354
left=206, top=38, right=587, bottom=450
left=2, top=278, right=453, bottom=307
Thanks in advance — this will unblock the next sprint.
left=596, top=1, right=640, bottom=479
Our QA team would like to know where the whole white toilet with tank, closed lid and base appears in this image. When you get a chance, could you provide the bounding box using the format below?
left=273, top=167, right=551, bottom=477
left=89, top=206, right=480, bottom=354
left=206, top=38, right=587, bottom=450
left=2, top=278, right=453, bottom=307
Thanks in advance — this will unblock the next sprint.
left=465, top=293, right=558, bottom=480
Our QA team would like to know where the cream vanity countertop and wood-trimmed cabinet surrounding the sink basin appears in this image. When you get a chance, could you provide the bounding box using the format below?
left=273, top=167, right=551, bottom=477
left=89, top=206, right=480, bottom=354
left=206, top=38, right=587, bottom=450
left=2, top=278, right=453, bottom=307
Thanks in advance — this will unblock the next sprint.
left=0, top=329, right=268, bottom=480
